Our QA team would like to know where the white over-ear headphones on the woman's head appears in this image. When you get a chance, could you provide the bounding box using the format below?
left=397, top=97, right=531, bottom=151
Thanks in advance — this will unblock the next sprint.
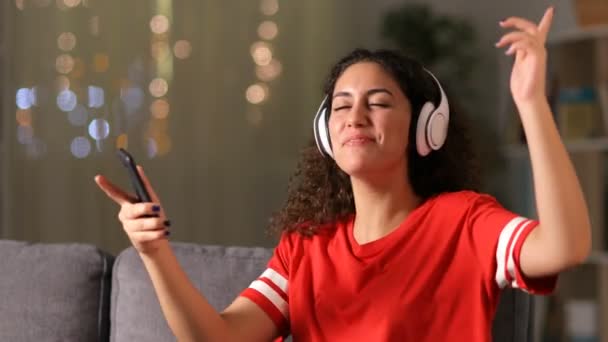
left=313, top=69, right=450, bottom=158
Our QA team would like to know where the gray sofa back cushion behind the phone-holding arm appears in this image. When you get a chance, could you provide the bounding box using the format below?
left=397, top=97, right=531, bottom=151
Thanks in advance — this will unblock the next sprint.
left=110, top=242, right=272, bottom=342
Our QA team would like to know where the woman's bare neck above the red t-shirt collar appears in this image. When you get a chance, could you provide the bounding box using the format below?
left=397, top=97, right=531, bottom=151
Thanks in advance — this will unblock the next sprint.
left=351, top=164, right=420, bottom=244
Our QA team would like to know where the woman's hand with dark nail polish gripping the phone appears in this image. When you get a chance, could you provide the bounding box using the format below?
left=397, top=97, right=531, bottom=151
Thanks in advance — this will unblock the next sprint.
left=95, top=166, right=170, bottom=255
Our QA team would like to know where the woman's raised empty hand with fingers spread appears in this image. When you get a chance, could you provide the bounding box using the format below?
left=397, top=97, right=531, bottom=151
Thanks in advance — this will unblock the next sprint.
left=496, top=7, right=554, bottom=107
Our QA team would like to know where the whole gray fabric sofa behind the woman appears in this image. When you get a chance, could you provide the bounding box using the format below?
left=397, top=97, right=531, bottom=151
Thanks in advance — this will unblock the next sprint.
left=0, top=240, right=532, bottom=342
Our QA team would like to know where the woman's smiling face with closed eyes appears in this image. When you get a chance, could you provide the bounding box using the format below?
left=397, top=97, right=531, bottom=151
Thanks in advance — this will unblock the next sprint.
left=329, top=62, right=411, bottom=176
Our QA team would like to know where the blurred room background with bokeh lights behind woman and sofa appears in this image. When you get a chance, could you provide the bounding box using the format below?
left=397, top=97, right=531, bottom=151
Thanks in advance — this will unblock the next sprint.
left=0, top=0, right=608, bottom=341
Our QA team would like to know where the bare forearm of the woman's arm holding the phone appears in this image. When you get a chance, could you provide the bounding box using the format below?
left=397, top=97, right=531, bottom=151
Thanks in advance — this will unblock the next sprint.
left=140, top=242, right=230, bottom=341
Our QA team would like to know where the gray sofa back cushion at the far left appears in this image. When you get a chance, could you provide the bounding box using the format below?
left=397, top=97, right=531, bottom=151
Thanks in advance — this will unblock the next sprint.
left=0, top=240, right=113, bottom=342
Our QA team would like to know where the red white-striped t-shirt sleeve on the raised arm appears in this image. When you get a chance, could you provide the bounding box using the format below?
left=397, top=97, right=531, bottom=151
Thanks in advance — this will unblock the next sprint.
left=467, top=195, right=557, bottom=295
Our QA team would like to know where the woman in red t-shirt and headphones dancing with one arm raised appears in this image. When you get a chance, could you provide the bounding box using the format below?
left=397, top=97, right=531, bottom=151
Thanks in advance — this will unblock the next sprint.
left=96, top=8, right=590, bottom=341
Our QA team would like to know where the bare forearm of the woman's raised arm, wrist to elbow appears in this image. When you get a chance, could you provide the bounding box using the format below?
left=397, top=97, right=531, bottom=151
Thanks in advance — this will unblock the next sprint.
left=518, top=99, right=591, bottom=264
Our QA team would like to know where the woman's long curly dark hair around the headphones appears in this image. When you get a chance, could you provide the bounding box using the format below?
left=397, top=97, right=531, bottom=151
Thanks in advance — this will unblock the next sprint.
left=270, top=49, right=481, bottom=236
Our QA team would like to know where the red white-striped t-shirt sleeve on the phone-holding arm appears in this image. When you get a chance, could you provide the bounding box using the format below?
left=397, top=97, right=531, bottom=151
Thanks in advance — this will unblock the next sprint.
left=240, top=234, right=290, bottom=334
